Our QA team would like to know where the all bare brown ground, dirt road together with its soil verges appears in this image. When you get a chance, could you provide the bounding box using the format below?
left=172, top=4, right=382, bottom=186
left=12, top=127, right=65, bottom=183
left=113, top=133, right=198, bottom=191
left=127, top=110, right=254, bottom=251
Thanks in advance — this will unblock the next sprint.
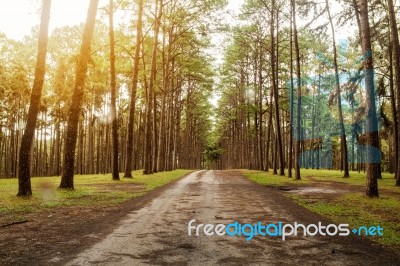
left=0, top=171, right=400, bottom=265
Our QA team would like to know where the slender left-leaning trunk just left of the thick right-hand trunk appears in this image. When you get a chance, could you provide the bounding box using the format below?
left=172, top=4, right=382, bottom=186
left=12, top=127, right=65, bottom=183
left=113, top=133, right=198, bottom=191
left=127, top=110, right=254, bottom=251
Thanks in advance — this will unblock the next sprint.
left=325, top=0, right=350, bottom=178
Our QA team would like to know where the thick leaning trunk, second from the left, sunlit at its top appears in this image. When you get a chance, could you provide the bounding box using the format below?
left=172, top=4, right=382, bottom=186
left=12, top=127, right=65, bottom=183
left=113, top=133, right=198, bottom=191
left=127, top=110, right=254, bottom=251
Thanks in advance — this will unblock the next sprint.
left=60, top=0, right=99, bottom=189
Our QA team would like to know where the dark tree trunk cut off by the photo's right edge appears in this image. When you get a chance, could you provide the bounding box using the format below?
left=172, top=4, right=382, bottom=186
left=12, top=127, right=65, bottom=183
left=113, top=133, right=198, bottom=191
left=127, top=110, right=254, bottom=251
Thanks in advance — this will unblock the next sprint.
left=388, top=0, right=400, bottom=186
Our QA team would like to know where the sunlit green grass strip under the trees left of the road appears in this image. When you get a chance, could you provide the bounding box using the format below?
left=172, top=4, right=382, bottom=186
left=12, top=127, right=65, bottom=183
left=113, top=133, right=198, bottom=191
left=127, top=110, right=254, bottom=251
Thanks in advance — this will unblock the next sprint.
left=0, top=170, right=191, bottom=220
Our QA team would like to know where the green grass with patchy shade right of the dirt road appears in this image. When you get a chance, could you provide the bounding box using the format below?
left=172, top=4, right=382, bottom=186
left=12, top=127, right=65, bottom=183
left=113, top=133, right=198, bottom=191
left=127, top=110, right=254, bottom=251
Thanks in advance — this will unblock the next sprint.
left=242, top=169, right=400, bottom=249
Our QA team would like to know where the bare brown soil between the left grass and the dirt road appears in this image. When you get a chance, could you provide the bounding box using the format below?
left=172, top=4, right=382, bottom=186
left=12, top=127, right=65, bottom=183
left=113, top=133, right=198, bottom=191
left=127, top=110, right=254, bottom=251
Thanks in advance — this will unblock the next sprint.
left=0, top=176, right=183, bottom=266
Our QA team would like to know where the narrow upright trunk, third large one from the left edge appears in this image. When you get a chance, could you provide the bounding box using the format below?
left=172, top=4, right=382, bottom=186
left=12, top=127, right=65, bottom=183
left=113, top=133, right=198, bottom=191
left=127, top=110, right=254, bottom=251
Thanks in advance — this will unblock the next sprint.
left=108, top=0, right=119, bottom=180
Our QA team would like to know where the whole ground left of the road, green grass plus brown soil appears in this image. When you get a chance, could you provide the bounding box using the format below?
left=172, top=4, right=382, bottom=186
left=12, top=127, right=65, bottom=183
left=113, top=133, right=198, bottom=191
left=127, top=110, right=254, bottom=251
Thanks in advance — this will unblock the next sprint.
left=0, top=170, right=192, bottom=266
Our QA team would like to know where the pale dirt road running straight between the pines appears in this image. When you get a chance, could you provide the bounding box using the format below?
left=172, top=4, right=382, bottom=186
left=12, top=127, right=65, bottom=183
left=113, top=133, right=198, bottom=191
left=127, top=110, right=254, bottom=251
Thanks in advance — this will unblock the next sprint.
left=67, top=171, right=400, bottom=265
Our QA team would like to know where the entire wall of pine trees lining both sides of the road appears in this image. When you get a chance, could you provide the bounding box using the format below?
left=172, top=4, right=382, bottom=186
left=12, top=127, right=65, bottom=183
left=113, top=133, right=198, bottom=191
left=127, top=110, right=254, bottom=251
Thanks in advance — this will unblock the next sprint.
left=0, top=0, right=400, bottom=196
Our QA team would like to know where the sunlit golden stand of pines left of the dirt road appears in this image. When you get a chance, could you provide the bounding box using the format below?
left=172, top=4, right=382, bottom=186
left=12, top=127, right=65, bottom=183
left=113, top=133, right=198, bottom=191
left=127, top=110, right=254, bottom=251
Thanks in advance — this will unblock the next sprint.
left=0, top=1, right=220, bottom=192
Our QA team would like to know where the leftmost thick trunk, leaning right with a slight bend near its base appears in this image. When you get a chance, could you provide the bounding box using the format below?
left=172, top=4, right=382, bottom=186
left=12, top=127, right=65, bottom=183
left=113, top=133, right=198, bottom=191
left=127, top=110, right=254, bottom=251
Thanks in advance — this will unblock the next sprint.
left=17, top=0, right=51, bottom=196
